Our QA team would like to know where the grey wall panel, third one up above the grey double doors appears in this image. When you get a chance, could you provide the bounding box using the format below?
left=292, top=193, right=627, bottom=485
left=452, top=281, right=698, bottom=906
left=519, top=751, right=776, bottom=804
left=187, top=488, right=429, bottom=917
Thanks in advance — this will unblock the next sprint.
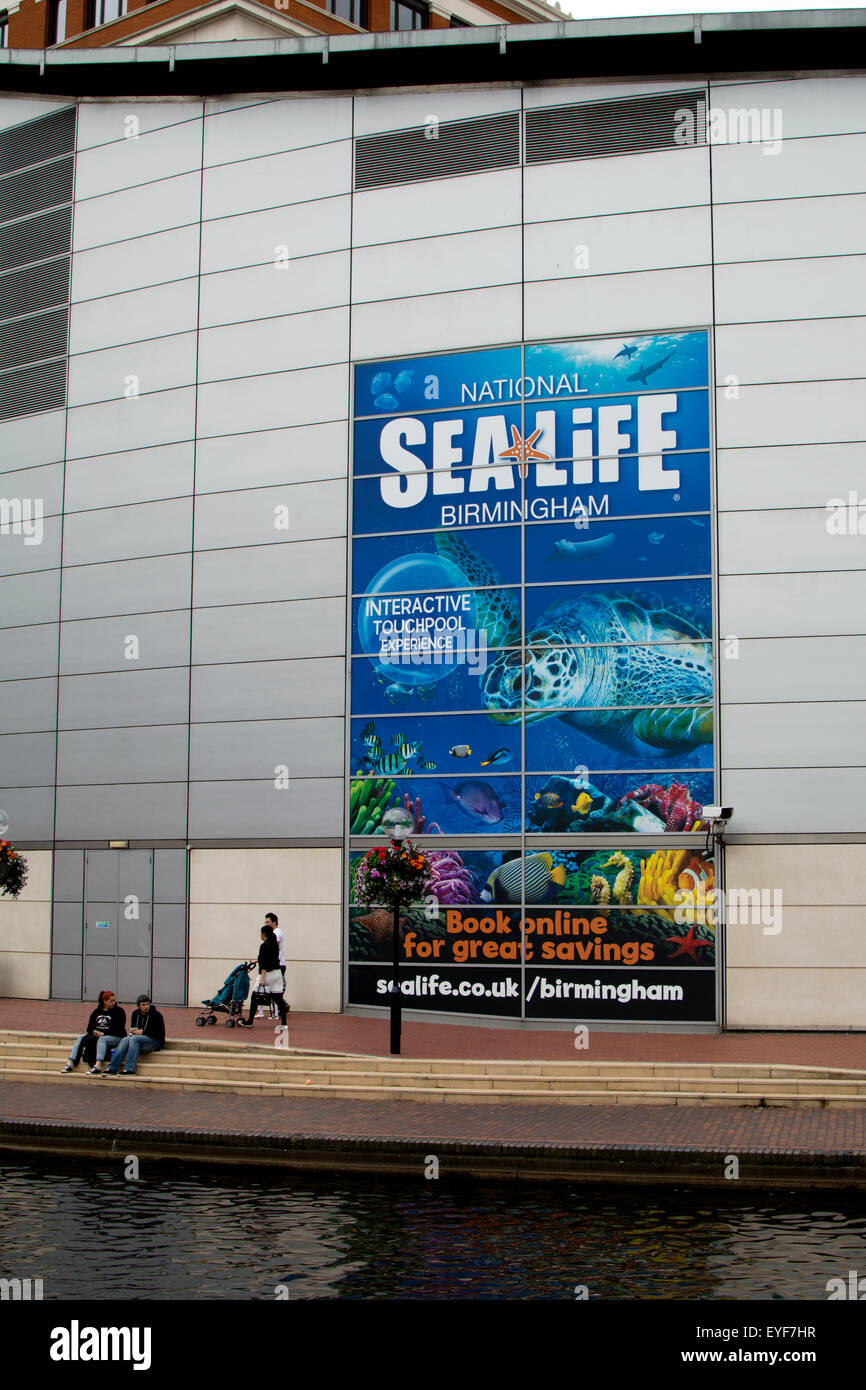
left=60, top=667, right=189, bottom=733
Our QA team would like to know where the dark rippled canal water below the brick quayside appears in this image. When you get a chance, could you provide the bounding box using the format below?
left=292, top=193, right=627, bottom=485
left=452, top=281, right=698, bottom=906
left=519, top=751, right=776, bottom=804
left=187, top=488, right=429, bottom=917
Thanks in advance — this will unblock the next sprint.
left=0, top=1155, right=866, bottom=1300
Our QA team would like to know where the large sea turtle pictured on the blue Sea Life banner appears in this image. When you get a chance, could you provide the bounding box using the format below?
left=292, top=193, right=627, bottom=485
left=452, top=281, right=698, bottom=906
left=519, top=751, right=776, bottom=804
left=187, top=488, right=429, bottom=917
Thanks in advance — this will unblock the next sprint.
left=481, top=594, right=713, bottom=756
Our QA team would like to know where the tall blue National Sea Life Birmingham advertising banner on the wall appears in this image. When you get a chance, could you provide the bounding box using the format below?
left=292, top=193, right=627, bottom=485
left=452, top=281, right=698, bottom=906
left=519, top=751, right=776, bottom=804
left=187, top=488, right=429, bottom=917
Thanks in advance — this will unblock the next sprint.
left=349, top=331, right=714, bottom=1022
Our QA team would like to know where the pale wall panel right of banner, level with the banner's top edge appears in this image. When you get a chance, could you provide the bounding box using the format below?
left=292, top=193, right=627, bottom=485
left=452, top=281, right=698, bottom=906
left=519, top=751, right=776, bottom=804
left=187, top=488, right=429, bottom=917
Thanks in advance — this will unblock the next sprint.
left=716, top=319, right=866, bottom=385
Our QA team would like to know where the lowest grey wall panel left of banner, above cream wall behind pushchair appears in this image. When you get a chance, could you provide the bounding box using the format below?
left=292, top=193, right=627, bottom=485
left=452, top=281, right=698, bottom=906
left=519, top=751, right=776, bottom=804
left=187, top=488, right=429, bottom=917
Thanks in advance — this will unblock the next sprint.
left=189, top=777, right=343, bottom=841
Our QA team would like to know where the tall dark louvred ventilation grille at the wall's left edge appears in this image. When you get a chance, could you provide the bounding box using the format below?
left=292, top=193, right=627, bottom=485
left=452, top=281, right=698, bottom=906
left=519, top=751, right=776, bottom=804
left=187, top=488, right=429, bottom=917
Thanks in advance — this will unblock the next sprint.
left=0, top=107, right=75, bottom=420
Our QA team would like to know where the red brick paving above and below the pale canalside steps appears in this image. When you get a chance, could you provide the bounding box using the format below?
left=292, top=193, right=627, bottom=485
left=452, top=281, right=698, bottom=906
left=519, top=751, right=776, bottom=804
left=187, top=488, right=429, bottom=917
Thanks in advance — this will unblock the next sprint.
left=0, top=999, right=866, bottom=1187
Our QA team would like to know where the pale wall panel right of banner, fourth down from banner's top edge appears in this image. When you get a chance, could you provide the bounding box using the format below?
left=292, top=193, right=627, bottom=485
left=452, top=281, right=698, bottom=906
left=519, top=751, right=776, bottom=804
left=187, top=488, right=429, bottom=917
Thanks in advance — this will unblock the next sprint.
left=719, top=508, right=866, bottom=582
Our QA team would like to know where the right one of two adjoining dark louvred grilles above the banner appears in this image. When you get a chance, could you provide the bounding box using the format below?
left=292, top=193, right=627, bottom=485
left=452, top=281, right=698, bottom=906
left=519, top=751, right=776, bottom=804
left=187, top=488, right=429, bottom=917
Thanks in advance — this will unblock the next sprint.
left=527, top=90, right=706, bottom=164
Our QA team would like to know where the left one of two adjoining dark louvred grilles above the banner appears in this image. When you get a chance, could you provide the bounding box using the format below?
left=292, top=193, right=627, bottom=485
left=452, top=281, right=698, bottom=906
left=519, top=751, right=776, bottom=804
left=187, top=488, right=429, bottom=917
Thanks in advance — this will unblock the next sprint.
left=354, top=111, right=520, bottom=188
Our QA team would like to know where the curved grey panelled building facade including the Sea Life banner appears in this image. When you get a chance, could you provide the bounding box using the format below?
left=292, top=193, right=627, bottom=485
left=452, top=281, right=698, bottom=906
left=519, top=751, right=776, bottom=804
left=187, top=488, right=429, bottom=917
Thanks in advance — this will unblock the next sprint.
left=0, top=15, right=866, bottom=1029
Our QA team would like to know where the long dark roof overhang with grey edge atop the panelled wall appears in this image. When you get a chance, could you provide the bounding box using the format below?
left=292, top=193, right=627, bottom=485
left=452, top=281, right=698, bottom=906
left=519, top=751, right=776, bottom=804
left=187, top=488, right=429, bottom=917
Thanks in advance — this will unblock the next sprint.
left=0, top=10, right=866, bottom=97
